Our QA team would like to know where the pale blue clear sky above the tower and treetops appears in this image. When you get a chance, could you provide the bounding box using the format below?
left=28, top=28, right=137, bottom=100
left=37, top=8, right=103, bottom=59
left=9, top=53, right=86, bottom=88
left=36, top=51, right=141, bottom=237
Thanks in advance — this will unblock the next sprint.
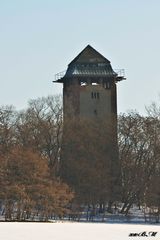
left=0, top=0, right=160, bottom=114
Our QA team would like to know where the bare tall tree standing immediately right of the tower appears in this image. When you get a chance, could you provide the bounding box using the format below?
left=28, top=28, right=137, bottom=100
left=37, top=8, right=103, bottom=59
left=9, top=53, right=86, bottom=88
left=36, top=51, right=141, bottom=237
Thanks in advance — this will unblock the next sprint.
left=118, top=112, right=160, bottom=214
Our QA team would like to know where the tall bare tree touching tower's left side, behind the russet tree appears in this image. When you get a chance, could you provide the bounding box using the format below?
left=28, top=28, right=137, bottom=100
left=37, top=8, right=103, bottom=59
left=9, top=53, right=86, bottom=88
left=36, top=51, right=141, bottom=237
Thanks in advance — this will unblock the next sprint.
left=16, top=96, right=63, bottom=175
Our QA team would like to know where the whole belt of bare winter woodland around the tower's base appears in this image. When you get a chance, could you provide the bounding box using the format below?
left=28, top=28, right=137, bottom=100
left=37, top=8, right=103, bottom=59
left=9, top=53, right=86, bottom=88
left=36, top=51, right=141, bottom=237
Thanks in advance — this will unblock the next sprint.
left=0, top=96, right=160, bottom=221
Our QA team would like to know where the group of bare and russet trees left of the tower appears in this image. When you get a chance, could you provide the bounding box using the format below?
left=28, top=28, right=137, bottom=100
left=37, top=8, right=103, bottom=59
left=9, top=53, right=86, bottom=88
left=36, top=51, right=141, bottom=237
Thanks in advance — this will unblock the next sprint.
left=0, top=97, right=73, bottom=221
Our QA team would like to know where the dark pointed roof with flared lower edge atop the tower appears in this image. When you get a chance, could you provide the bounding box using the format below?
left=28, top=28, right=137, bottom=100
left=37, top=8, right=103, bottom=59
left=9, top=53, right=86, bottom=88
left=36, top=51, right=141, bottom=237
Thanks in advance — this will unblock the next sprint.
left=55, top=45, right=123, bottom=82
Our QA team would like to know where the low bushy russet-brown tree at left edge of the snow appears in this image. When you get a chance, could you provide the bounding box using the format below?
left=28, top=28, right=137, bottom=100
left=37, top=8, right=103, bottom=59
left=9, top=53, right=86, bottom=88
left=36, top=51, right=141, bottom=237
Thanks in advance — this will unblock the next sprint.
left=0, top=148, right=73, bottom=221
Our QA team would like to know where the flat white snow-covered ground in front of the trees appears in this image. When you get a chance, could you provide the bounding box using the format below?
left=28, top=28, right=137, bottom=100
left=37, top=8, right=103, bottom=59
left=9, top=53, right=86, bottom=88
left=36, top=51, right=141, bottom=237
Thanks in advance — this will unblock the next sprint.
left=0, top=222, right=160, bottom=240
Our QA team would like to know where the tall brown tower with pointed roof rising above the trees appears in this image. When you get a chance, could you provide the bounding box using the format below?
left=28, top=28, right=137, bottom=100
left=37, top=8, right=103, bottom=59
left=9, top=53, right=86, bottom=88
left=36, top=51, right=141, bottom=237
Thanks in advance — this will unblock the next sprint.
left=54, top=45, right=124, bottom=205
